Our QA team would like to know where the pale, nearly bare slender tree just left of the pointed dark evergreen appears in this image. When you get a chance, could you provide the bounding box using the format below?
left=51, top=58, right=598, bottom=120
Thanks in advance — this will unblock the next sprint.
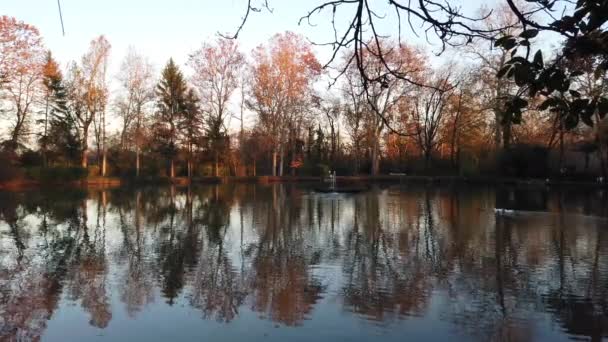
left=116, top=48, right=154, bottom=176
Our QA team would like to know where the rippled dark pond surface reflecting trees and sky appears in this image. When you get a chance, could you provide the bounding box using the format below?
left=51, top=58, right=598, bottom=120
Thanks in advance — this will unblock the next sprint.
left=0, top=185, right=608, bottom=341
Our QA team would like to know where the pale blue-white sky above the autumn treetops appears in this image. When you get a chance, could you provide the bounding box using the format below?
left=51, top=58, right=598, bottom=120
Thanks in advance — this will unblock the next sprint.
left=0, top=0, right=495, bottom=132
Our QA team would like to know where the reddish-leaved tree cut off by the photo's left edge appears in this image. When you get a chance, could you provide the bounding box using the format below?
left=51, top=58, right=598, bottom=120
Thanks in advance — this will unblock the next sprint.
left=0, top=16, right=45, bottom=151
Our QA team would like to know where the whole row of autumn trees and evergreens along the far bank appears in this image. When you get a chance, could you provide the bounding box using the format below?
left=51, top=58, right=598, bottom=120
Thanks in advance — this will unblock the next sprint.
left=0, top=5, right=608, bottom=178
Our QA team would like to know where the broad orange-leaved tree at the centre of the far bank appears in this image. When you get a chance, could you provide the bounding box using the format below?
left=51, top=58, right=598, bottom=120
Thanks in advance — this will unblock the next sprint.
left=247, top=32, right=321, bottom=176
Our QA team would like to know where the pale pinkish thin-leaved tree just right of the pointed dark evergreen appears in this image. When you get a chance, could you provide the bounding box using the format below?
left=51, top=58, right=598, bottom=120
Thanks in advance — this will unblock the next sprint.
left=189, top=38, right=245, bottom=176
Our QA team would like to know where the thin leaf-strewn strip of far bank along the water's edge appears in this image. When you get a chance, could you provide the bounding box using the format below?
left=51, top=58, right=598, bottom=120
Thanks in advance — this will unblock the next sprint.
left=0, top=175, right=608, bottom=191
